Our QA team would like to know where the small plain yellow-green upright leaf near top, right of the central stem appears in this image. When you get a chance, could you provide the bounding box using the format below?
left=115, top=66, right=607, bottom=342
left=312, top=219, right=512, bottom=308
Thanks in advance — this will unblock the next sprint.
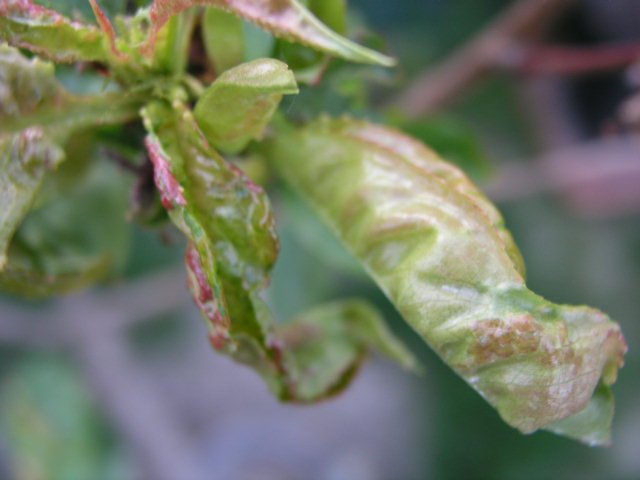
left=202, top=8, right=245, bottom=74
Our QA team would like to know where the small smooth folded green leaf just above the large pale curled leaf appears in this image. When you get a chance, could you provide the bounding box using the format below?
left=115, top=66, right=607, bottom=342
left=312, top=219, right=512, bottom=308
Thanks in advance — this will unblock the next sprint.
left=194, top=58, right=298, bottom=153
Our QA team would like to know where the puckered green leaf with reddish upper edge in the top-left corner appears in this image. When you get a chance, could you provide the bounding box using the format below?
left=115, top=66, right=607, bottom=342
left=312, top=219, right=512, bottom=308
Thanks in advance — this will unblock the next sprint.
left=0, top=0, right=116, bottom=63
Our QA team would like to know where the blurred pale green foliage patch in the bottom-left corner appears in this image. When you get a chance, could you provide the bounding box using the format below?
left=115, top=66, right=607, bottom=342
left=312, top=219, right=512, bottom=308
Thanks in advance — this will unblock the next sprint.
left=0, top=355, right=132, bottom=480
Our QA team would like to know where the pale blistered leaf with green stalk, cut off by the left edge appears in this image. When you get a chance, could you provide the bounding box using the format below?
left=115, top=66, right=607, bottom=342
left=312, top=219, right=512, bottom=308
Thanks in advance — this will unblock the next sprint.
left=0, top=45, right=138, bottom=270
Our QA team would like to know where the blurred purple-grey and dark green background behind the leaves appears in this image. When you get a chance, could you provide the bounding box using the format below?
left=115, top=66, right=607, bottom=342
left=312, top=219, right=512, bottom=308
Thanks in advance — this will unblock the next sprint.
left=0, top=0, right=640, bottom=480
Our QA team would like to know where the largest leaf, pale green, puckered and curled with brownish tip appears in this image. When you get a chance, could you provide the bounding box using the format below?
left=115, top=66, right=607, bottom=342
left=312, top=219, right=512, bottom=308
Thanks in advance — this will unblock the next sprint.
left=267, top=115, right=627, bottom=444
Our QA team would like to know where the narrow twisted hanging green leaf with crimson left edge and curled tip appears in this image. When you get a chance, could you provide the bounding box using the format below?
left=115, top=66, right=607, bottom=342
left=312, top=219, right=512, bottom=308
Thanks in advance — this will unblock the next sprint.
left=143, top=100, right=413, bottom=402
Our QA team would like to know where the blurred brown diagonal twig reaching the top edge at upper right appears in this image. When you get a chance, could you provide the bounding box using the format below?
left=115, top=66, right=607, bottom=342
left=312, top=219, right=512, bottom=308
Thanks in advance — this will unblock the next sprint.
left=390, top=0, right=575, bottom=118
